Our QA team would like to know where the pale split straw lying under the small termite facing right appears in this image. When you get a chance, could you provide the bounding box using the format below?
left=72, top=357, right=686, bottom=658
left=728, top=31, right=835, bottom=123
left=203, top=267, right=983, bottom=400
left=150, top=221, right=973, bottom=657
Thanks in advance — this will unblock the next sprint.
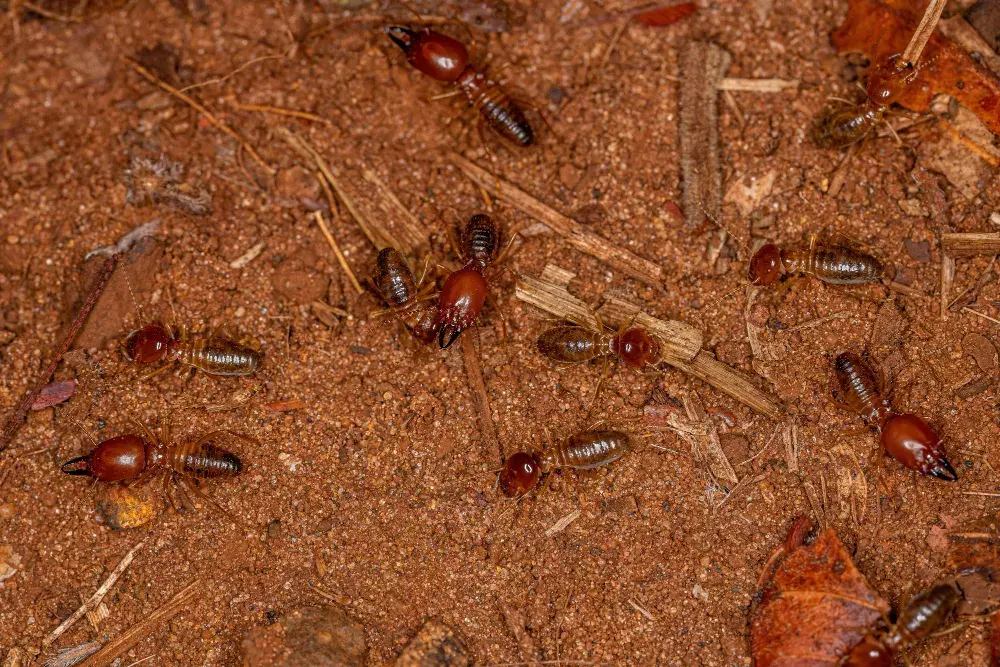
left=515, top=264, right=784, bottom=419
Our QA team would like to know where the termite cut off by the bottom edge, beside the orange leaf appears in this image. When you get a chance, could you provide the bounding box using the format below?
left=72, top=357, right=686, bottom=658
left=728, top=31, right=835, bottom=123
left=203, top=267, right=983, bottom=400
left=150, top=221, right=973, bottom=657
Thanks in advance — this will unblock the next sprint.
left=840, top=584, right=958, bottom=667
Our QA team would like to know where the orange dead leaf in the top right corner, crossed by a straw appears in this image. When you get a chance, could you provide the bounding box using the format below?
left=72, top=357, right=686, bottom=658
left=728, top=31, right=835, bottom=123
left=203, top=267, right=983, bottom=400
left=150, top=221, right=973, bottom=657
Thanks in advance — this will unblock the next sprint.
left=832, top=0, right=1000, bottom=134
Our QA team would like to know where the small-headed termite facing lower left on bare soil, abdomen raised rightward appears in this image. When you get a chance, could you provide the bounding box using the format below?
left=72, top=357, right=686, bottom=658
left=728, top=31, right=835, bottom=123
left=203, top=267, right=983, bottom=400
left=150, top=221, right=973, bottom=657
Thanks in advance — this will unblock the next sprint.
left=500, top=429, right=631, bottom=498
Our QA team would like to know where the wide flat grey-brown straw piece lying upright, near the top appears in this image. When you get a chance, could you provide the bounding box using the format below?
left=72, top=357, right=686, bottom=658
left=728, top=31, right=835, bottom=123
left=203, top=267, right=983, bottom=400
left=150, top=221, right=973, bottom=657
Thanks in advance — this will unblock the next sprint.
left=680, top=41, right=732, bottom=227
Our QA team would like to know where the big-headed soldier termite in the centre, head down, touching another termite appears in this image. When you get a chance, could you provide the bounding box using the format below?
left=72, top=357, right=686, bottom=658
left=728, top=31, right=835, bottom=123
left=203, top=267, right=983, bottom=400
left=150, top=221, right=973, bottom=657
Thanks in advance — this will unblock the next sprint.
left=434, top=213, right=513, bottom=349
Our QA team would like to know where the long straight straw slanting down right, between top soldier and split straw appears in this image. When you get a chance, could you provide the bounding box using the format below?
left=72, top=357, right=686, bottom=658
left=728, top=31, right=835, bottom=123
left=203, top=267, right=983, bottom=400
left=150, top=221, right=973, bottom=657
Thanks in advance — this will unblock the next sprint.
left=448, top=153, right=663, bottom=289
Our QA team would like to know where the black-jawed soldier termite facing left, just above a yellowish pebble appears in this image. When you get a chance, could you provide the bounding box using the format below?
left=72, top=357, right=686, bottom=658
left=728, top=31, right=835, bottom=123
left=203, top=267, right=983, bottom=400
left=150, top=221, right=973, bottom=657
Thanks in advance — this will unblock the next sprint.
left=60, top=424, right=252, bottom=516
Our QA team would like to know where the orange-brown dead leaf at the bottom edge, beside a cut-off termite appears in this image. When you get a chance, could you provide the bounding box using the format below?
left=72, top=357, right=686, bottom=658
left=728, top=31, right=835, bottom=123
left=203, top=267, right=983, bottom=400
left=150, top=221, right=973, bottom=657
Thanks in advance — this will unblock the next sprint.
left=750, top=528, right=889, bottom=667
